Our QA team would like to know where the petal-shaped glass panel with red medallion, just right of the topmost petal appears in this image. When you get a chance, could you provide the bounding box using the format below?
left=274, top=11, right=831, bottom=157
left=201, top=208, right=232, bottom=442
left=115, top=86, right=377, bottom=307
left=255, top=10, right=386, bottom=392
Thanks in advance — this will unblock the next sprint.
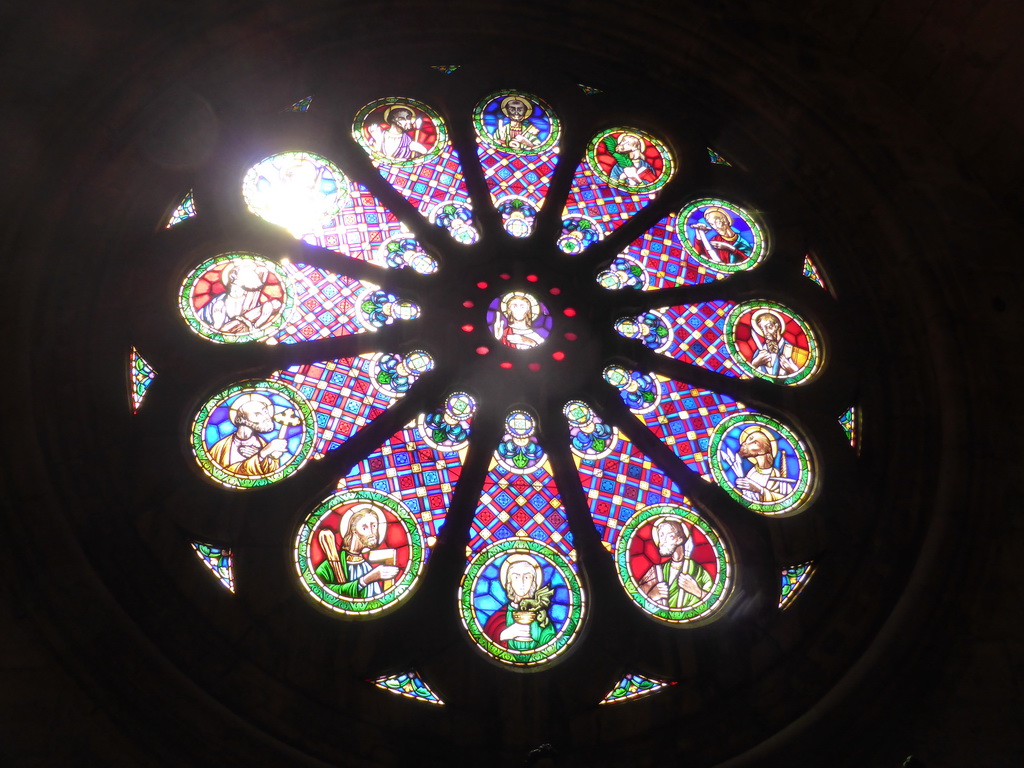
left=558, top=127, right=675, bottom=254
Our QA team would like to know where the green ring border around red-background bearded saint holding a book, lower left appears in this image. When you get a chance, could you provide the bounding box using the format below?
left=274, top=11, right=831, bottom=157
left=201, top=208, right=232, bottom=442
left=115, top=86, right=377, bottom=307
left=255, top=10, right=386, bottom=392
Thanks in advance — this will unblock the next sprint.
left=295, top=488, right=425, bottom=618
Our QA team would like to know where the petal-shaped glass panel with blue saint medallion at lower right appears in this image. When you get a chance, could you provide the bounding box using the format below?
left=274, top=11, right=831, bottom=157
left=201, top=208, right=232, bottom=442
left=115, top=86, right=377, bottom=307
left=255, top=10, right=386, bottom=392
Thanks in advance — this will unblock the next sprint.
left=604, top=366, right=816, bottom=515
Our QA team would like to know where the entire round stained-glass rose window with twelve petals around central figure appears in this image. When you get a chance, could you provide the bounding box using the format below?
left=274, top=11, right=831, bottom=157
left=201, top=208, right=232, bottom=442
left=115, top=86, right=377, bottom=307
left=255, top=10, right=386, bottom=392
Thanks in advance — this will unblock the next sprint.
left=144, top=79, right=858, bottom=684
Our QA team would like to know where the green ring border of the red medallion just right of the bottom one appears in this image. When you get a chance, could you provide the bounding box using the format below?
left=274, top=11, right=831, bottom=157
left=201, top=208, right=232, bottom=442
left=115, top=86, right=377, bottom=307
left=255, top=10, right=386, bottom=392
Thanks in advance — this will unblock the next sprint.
left=614, top=504, right=732, bottom=624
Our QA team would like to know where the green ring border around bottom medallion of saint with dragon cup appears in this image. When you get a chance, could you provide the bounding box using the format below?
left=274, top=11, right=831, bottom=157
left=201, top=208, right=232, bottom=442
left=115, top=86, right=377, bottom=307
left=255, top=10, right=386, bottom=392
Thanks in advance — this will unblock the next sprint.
left=459, top=538, right=587, bottom=667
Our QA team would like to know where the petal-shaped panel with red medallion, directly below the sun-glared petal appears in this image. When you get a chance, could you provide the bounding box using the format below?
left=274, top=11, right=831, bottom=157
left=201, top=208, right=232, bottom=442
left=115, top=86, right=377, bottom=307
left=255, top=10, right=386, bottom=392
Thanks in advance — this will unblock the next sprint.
left=178, top=253, right=420, bottom=344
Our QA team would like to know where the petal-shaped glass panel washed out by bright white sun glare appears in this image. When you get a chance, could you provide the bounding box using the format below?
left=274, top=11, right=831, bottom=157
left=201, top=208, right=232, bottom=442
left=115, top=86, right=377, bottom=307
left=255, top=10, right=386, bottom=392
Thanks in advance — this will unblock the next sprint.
left=242, top=152, right=437, bottom=274
